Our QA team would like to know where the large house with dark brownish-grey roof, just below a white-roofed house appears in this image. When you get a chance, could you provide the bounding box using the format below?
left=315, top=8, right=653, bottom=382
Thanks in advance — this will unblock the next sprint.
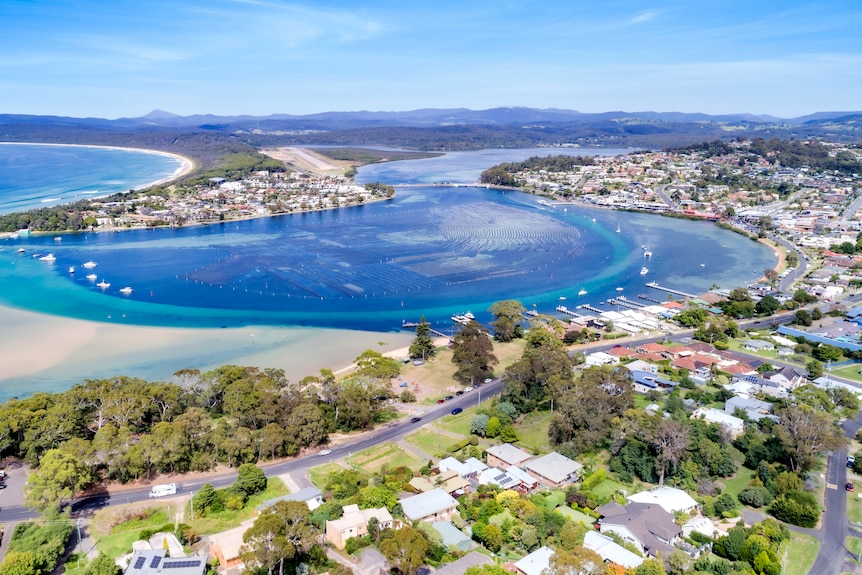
left=596, top=502, right=682, bottom=557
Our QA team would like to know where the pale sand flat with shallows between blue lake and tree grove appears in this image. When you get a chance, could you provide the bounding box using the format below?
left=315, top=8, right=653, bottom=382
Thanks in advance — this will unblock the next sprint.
left=0, top=307, right=413, bottom=401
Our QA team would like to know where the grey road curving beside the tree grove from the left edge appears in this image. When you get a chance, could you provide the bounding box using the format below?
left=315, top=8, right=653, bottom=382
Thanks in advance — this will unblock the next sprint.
left=0, top=379, right=502, bottom=524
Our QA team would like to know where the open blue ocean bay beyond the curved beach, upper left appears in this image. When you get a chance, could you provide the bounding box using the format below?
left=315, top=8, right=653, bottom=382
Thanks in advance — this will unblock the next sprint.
left=0, top=143, right=182, bottom=214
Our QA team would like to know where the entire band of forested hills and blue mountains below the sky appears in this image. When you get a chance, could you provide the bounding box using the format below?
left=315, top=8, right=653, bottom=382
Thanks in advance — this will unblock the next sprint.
left=0, top=108, right=862, bottom=158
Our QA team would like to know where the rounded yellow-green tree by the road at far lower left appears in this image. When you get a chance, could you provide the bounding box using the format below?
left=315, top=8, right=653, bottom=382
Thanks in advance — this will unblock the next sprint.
left=24, top=449, right=95, bottom=513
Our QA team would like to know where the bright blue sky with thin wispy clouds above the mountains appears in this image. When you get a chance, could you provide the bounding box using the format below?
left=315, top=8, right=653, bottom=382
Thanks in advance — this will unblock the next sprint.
left=0, top=0, right=862, bottom=118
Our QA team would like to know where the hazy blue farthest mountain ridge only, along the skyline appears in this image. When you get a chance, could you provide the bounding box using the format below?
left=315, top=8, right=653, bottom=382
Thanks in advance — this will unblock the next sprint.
left=0, top=107, right=862, bottom=130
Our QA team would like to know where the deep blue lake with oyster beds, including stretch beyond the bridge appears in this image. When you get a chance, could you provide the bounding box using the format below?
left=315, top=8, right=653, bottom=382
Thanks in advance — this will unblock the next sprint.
left=0, top=145, right=774, bottom=333
